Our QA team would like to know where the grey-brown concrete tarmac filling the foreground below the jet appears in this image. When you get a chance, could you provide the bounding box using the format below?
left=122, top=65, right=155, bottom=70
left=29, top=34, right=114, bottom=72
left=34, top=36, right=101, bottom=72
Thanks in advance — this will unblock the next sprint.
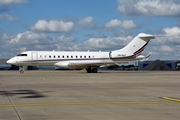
left=0, top=71, right=180, bottom=120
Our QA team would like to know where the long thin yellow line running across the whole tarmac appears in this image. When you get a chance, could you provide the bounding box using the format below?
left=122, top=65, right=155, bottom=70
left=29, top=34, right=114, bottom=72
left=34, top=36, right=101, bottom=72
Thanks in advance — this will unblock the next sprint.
left=0, top=101, right=179, bottom=107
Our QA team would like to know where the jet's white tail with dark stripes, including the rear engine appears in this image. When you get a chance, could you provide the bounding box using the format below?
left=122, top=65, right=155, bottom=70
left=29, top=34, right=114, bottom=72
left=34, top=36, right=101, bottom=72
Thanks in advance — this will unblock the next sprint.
left=110, top=33, right=155, bottom=61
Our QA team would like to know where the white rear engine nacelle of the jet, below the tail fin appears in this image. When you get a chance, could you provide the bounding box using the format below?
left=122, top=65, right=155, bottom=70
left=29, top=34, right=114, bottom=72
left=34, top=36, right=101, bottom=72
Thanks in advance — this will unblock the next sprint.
left=109, top=51, right=134, bottom=60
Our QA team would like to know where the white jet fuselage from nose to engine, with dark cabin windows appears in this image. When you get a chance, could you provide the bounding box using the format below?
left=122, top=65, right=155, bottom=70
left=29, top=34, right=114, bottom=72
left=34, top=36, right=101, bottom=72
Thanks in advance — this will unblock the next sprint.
left=7, top=51, right=136, bottom=68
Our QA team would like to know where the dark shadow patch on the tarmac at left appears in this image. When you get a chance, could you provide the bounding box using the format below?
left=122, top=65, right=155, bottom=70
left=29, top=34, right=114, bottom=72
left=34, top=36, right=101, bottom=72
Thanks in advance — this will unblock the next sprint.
left=0, top=90, right=47, bottom=98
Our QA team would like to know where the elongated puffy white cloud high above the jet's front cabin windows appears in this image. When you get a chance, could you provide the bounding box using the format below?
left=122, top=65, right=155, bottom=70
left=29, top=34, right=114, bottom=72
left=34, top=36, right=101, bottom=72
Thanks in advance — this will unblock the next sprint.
left=31, top=20, right=74, bottom=32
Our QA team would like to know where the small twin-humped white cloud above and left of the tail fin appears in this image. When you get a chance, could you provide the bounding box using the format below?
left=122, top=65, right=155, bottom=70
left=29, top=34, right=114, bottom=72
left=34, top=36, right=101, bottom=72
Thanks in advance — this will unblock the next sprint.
left=105, top=19, right=137, bottom=29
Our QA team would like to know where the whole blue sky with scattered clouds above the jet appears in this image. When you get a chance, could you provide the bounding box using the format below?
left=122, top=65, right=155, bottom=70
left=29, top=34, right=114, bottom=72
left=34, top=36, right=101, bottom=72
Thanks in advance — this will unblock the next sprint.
left=0, top=0, right=180, bottom=60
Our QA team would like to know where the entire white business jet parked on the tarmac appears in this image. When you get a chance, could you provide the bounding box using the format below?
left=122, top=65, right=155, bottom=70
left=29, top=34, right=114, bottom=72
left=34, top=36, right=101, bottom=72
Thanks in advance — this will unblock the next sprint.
left=7, top=33, right=155, bottom=74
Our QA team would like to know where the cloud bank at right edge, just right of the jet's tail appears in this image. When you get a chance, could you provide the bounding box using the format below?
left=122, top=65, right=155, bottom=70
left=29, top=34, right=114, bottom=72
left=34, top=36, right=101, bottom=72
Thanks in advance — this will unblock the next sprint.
left=146, top=27, right=180, bottom=60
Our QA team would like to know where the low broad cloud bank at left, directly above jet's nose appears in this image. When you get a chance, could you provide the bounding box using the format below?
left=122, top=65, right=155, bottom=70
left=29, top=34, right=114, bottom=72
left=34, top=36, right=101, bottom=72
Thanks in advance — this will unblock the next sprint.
left=0, top=31, right=77, bottom=57
